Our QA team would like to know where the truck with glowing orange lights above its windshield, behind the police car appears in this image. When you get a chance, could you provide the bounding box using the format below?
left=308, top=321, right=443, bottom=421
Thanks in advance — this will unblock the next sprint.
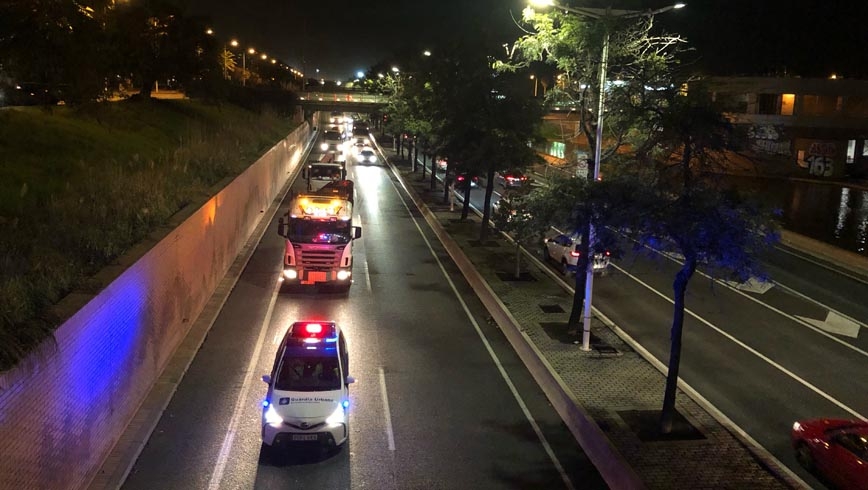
left=277, top=181, right=362, bottom=291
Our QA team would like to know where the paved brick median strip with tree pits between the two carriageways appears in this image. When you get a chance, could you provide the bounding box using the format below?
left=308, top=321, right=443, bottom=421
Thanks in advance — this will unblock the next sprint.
left=383, top=147, right=804, bottom=490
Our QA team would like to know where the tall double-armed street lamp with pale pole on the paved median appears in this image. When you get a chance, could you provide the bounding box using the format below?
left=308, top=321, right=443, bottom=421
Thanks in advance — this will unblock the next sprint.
left=530, top=0, right=685, bottom=350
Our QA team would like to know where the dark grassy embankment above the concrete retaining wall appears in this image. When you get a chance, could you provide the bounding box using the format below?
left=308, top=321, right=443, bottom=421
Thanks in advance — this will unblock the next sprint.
left=0, top=100, right=296, bottom=371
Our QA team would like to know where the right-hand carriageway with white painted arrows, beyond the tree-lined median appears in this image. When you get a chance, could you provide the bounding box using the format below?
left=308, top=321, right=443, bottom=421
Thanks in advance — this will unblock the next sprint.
left=471, top=167, right=868, bottom=488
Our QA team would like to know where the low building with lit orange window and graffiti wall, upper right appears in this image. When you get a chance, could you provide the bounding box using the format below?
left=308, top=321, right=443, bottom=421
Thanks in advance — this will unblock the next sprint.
left=689, top=77, right=868, bottom=179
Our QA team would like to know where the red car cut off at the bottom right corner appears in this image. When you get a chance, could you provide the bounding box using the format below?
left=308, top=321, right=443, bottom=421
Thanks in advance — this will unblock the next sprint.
left=792, top=419, right=868, bottom=490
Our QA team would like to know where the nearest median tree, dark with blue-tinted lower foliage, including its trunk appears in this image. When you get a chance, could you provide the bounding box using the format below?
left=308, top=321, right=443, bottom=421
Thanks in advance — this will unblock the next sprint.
left=620, top=95, right=778, bottom=433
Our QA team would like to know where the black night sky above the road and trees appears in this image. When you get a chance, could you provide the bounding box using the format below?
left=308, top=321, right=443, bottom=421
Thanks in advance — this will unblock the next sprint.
left=175, top=0, right=868, bottom=79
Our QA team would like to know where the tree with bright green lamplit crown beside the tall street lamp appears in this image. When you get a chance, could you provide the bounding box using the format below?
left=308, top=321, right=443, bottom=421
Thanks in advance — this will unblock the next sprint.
left=498, top=5, right=684, bottom=327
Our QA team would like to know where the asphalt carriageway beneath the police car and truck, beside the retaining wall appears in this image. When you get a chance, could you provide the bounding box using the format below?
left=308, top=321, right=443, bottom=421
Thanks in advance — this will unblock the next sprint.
left=123, top=119, right=605, bottom=490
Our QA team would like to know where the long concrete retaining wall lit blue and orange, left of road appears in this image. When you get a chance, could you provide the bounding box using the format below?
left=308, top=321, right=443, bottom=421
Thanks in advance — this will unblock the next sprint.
left=0, top=123, right=311, bottom=490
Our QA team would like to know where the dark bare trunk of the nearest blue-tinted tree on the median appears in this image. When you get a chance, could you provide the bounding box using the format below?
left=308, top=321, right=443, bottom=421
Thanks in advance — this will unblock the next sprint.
left=660, top=251, right=696, bottom=434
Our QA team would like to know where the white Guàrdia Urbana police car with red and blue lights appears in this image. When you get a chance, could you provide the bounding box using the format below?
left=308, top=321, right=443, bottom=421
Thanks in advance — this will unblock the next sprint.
left=262, top=321, right=355, bottom=451
